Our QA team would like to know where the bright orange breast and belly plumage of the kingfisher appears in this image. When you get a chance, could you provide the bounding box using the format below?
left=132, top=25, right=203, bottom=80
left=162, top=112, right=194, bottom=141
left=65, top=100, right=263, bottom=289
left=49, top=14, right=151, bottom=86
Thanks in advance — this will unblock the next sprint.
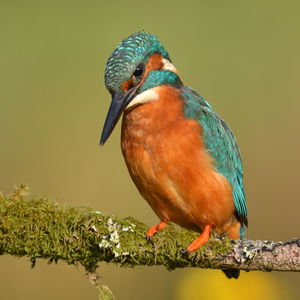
left=122, top=86, right=236, bottom=233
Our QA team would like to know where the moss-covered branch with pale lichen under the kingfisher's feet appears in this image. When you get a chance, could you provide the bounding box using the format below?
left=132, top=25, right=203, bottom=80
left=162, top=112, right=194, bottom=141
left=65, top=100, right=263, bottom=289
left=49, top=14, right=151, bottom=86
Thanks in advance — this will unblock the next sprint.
left=0, top=189, right=300, bottom=272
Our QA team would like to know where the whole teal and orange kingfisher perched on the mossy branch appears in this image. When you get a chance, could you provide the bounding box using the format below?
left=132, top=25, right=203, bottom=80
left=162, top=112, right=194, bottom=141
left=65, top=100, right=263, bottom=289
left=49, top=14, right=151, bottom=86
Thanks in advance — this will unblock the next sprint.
left=100, top=31, right=248, bottom=278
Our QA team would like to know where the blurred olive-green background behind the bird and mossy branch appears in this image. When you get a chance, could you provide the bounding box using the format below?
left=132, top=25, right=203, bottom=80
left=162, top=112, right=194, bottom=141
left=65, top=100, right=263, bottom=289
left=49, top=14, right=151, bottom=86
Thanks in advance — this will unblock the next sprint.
left=0, top=0, right=300, bottom=300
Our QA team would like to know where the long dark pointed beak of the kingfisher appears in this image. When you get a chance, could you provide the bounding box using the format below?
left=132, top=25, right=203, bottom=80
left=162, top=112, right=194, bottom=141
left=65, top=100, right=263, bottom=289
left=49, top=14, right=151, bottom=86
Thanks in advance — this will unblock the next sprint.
left=100, top=87, right=138, bottom=145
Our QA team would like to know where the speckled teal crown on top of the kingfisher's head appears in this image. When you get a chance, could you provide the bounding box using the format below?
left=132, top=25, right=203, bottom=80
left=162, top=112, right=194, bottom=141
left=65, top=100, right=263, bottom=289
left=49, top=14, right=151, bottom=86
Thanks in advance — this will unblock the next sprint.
left=105, top=31, right=170, bottom=91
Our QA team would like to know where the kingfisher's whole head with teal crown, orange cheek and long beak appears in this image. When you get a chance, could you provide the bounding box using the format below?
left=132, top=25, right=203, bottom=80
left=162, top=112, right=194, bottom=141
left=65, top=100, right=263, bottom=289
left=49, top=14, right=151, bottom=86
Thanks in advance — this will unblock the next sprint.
left=100, top=31, right=182, bottom=145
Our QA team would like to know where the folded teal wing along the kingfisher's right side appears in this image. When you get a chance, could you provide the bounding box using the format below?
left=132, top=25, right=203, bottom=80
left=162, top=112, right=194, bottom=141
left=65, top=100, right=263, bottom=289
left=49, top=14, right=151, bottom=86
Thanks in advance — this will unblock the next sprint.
left=182, top=87, right=248, bottom=226
